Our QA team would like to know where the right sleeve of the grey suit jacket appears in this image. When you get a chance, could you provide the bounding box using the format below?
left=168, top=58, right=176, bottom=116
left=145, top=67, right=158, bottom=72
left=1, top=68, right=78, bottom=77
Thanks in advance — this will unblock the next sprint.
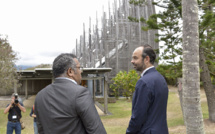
left=76, top=88, right=106, bottom=134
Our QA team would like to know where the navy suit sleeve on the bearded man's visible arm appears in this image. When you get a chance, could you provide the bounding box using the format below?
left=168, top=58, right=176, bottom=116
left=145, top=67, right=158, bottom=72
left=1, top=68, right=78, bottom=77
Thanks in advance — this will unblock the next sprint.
left=126, top=80, right=152, bottom=134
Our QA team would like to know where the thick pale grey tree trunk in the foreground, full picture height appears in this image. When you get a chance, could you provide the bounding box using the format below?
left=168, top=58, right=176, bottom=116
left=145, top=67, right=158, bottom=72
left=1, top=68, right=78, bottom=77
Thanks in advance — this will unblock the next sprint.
left=182, top=0, right=204, bottom=134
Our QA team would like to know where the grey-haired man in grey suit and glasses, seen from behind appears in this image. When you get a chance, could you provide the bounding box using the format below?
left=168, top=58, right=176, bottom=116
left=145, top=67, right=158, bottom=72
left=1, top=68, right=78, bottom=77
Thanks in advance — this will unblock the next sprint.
left=35, top=53, right=106, bottom=134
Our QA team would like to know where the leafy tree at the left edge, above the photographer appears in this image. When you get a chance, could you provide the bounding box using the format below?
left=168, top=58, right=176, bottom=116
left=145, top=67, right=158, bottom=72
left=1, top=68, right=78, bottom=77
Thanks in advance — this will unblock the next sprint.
left=0, top=35, right=18, bottom=92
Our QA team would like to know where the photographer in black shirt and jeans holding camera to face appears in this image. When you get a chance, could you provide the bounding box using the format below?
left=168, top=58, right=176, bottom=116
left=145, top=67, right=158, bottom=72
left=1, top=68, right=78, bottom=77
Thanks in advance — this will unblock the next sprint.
left=4, top=93, right=26, bottom=134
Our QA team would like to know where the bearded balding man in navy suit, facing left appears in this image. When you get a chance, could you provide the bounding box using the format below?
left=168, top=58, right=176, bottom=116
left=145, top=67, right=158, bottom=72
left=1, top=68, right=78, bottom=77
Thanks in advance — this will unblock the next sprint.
left=126, top=45, right=168, bottom=134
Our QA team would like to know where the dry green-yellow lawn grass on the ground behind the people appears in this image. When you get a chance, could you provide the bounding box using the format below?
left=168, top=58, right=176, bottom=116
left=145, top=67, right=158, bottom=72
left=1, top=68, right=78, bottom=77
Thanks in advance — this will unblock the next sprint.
left=0, top=92, right=211, bottom=134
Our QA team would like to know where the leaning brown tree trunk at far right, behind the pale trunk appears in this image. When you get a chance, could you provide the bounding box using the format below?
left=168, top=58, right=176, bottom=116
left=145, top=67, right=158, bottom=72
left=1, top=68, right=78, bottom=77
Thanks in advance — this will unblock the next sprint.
left=199, top=47, right=215, bottom=122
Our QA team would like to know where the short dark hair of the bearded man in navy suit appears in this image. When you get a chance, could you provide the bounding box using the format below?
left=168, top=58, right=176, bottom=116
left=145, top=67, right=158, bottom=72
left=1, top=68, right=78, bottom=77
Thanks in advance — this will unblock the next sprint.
left=141, top=44, right=156, bottom=65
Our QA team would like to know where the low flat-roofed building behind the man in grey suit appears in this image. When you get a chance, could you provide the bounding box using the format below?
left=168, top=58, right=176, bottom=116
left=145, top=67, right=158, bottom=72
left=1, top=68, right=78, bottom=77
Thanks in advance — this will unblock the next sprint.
left=8, top=68, right=112, bottom=114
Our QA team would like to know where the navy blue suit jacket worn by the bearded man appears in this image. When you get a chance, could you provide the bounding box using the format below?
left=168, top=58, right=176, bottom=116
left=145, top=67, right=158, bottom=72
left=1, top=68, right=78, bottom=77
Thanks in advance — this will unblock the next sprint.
left=126, top=68, right=168, bottom=134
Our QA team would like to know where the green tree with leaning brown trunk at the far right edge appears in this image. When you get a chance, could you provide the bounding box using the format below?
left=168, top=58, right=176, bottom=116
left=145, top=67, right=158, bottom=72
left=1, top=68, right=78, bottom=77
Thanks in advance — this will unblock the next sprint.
left=199, top=0, right=215, bottom=122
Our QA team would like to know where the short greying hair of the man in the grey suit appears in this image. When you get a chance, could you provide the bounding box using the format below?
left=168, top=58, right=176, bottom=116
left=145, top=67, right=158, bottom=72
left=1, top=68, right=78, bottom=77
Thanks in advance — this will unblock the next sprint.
left=52, top=53, right=77, bottom=78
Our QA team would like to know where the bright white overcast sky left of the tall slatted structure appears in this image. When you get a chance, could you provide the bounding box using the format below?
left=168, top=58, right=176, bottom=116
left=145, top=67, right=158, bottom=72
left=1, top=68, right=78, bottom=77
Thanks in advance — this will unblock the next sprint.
left=0, top=0, right=114, bottom=66
